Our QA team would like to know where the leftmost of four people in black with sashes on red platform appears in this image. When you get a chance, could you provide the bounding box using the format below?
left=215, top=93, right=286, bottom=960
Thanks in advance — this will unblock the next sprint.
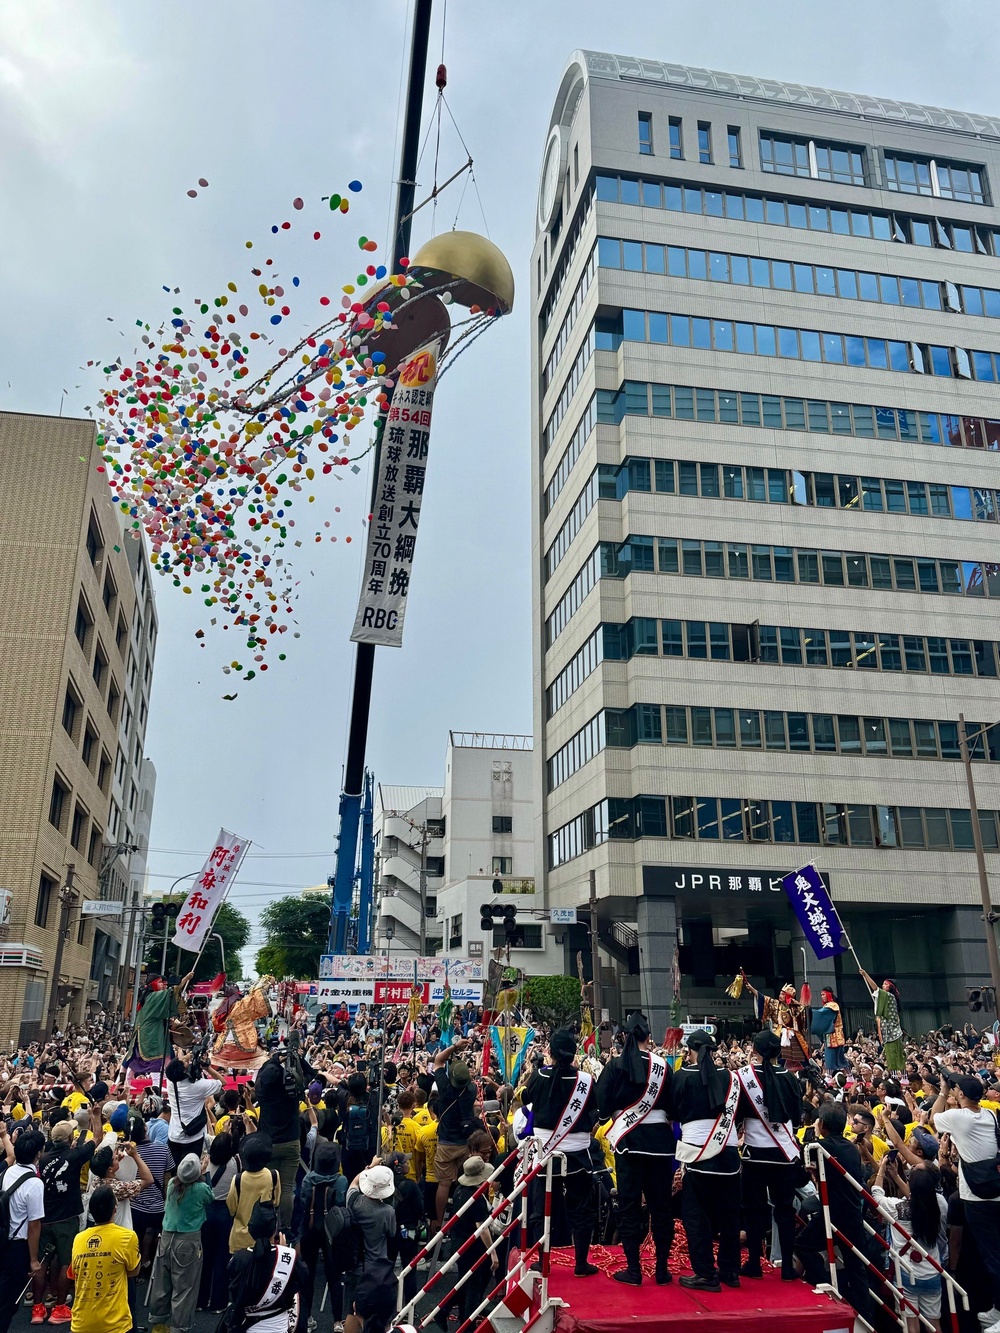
left=521, top=1028, right=600, bottom=1277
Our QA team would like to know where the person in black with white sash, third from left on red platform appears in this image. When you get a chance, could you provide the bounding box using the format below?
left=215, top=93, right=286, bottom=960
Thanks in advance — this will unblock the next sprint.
left=671, top=1028, right=743, bottom=1292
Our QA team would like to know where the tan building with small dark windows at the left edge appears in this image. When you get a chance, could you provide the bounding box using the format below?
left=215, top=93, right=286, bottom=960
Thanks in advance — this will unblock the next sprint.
left=0, top=412, right=156, bottom=1042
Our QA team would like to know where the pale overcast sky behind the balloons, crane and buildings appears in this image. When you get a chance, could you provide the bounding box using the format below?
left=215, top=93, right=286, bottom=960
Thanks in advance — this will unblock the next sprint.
left=0, top=0, right=1000, bottom=964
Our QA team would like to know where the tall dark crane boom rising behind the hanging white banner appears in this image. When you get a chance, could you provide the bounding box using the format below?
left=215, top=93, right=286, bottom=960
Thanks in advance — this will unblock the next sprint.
left=329, top=0, right=431, bottom=953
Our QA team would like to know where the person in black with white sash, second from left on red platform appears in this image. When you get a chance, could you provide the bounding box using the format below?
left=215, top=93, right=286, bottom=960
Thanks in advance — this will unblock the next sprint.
left=597, top=1012, right=676, bottom=1286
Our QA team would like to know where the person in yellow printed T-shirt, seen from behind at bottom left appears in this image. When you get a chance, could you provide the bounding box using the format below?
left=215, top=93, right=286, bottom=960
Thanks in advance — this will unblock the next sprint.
left=69, top=1185, right=139, bottom=1333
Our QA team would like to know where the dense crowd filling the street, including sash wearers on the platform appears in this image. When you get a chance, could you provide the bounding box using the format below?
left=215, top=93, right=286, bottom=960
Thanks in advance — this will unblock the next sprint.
left=0, top=982, right=1000, bottom=1333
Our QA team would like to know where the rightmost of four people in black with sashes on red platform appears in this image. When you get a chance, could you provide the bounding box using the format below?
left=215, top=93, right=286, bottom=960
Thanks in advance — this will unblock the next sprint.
left=739, top=1030, right=803, bottom=1282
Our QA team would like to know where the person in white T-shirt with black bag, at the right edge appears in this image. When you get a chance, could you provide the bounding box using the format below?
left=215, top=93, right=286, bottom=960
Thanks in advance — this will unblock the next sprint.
left=931, top=1069, right=1000, bottom=1333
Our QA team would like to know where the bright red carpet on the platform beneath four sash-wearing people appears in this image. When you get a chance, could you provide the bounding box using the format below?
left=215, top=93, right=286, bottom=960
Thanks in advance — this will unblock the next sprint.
left=549, top=1245, right=855, bottom=1333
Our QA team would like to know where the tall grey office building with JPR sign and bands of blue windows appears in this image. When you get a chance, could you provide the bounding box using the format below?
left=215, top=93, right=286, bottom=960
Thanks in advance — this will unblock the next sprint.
left=532, top=52, right=1000, bottom=1030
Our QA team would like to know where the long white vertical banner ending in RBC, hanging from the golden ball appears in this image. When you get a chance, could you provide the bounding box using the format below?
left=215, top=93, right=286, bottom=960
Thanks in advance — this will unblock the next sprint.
left=351, top=343, right=439, bottom=648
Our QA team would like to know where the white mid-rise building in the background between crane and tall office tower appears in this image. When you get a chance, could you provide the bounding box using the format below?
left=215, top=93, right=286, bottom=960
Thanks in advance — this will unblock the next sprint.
left=375, top=732, right=564, bottom=976
